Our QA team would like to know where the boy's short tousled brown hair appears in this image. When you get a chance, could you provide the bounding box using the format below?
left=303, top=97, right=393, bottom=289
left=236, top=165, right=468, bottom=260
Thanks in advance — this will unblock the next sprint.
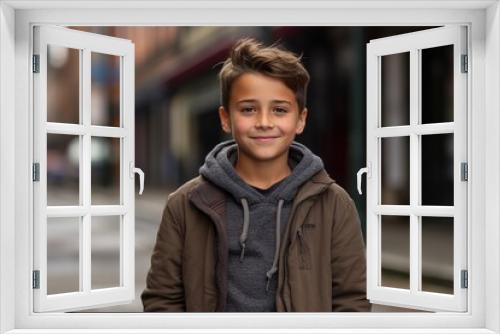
left=219, top=38, right=309, bottom=112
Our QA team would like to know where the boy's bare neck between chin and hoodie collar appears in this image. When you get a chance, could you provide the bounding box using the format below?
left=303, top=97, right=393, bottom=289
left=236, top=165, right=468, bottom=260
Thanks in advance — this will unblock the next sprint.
left=235, top=152, right=291, bottom=189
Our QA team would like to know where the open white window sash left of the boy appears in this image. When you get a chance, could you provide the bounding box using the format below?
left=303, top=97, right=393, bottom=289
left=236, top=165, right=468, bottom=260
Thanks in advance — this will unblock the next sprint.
left=33, top=26, right=135, bottom=312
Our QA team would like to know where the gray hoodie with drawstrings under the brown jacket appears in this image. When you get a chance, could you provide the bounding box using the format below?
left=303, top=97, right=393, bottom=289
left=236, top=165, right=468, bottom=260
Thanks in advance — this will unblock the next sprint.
left=200, top=140, right=323, bottom=312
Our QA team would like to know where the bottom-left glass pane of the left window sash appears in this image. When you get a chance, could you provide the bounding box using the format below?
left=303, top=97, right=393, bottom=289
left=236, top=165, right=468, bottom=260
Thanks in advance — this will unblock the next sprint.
left=47, top=217, right=80, bottom=295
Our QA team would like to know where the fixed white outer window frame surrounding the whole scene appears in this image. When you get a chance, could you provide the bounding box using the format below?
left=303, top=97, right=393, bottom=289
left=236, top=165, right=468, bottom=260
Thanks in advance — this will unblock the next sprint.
left=0, top=0, right=500, bottom=334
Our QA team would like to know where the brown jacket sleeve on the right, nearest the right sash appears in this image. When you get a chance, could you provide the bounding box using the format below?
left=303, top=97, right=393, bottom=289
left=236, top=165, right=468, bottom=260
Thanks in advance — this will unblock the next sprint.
left=331, top=192, right=371, bottom=312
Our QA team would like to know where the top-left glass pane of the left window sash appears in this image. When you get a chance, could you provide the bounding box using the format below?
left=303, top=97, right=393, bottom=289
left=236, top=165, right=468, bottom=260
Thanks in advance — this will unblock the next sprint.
left=47, top=45, right=80, bottom=124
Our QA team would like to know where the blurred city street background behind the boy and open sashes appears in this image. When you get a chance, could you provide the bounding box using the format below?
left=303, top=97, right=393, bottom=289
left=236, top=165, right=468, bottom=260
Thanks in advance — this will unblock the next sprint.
left=47, top=26, right=453, bottom=312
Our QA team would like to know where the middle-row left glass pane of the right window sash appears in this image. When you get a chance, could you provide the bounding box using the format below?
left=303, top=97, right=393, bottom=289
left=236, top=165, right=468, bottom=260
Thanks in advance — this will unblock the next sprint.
left=381, top=137, right=410, bottom=205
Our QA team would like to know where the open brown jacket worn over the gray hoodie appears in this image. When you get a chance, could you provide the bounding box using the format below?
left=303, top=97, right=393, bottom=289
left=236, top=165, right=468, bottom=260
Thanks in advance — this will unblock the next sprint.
left=141, top=170, right=370, bottom=312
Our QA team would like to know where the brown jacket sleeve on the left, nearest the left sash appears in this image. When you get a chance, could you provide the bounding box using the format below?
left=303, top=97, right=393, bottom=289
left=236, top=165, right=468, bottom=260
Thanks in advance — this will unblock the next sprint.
left=141, top=197, right=186, bottom=312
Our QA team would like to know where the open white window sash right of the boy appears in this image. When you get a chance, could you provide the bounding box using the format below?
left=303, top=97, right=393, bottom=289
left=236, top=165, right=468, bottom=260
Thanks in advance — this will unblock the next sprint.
left=367, top=26, right=468, bottom=312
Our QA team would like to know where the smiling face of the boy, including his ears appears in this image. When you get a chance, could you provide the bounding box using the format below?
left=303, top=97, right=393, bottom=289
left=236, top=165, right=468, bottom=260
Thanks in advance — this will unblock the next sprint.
left=219, top=73, right=307, bottom=161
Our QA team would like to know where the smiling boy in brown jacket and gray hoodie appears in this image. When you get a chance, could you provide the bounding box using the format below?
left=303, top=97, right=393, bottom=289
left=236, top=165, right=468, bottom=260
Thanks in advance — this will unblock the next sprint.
left=142, top=39, right=370, bottom=312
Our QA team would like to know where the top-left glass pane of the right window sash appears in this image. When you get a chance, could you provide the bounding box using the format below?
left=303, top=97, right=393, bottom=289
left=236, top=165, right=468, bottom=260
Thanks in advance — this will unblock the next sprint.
left=380, top=52, right=410, bottom=126
